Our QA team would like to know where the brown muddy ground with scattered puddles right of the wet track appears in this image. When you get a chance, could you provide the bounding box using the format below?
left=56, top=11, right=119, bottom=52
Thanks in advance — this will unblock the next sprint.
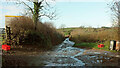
left=74, top=47, right=120, bottom=67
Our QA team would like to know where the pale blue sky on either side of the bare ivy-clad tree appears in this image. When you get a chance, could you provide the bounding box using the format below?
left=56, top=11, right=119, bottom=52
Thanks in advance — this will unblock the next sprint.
left=0, top=0, right=112, bottom=28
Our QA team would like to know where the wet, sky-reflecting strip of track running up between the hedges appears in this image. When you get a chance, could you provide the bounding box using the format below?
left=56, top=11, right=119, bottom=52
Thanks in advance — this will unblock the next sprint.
left=46, top=37, right=85, bottom=66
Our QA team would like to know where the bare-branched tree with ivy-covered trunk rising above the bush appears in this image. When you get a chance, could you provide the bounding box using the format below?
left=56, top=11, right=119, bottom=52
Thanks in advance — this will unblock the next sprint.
left=17, top=0, right=56, bottom=30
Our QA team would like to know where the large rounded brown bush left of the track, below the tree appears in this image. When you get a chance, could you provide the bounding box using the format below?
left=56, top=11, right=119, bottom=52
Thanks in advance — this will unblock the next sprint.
left=9, top=16, right=64, bottom=48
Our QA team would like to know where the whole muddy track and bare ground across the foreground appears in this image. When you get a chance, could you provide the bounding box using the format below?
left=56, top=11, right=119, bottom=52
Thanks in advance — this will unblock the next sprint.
left=2, top=39, right=120, bottom=67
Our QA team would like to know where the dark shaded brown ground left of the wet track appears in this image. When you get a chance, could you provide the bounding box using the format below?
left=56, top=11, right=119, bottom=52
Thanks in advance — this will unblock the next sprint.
left=2, top=45, right=52, bottom=68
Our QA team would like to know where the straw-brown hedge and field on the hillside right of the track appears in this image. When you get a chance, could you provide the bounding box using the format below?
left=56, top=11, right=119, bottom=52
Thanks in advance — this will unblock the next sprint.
left=58, top=28, right=118, bottom=42
